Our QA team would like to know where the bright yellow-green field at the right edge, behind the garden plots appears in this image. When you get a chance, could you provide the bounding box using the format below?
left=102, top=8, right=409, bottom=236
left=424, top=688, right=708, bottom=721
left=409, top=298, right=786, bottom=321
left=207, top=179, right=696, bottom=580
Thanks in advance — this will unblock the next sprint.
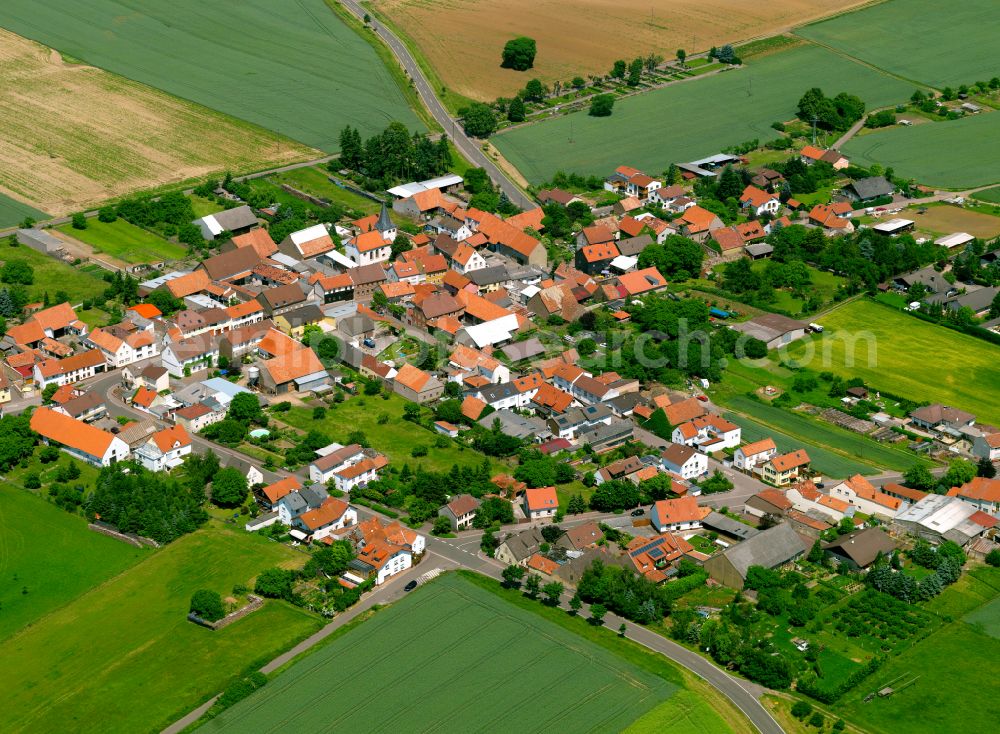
left=788, top=300, right=1000, bottom=424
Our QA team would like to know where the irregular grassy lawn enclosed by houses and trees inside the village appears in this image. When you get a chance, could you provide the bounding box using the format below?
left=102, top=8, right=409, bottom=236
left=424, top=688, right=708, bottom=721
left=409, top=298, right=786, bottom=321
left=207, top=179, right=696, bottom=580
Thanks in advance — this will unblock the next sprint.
left=274, top=394, right=502, bottom=472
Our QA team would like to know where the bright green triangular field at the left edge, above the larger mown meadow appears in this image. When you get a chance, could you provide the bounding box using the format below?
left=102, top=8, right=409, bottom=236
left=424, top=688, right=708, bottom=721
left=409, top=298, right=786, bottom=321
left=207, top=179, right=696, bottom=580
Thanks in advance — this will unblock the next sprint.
left=0, top=482, right=149, bottom=640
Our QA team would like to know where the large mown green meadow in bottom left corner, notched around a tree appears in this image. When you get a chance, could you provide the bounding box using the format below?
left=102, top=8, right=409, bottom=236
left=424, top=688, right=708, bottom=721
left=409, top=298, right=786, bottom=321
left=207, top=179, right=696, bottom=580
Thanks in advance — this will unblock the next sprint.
left=0, top=525, right=320, bottom=732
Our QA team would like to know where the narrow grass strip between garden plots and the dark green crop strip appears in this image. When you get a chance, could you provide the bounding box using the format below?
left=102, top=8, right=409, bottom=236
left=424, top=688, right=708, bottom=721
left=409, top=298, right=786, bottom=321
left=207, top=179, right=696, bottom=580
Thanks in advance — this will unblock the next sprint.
left=724, top=395, right=920, bottom=478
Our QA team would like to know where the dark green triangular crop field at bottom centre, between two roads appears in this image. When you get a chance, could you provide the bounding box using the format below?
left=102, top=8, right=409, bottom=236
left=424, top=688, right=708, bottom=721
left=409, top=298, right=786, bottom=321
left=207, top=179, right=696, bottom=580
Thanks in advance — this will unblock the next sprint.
left=203, top=574, right=679, bottom=734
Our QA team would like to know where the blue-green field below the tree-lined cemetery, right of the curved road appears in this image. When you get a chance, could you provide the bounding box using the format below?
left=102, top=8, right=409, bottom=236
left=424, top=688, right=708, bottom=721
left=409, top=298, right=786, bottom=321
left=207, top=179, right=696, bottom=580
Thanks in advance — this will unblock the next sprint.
left=493, top=46, right=913, bottom=183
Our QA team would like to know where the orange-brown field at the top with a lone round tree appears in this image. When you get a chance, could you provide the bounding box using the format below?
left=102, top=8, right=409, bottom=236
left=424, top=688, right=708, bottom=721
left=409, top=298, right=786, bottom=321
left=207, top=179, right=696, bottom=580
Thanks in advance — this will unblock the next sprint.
left=374, top=0, right=864, bottom=100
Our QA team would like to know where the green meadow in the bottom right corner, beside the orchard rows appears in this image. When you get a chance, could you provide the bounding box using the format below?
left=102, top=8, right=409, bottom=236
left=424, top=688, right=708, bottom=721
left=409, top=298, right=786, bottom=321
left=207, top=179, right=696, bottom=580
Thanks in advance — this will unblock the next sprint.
left=837, top=567, right=1000, bottom=734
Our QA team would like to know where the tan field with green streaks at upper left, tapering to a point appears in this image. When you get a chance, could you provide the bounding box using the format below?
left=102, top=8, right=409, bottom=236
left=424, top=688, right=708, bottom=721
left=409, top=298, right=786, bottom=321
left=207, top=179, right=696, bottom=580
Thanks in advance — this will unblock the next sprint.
left=0, top=29, right=319, bottom=215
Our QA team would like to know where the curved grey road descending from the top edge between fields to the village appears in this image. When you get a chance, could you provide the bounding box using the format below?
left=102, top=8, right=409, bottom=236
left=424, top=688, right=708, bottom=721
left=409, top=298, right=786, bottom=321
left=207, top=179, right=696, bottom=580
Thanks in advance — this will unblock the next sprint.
left=340, top=0, right=537, bottom=209
